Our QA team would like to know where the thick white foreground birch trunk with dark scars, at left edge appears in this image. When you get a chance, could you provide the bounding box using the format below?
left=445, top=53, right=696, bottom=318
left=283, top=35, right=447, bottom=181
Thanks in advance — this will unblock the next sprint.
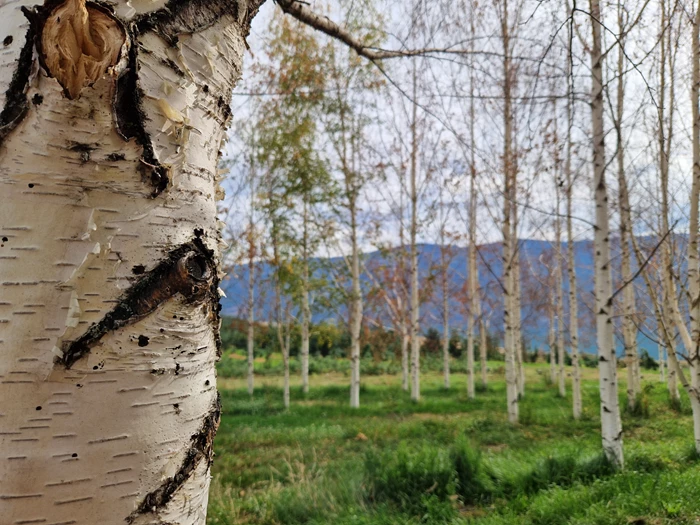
left=0, top=0, right=257, bottom=525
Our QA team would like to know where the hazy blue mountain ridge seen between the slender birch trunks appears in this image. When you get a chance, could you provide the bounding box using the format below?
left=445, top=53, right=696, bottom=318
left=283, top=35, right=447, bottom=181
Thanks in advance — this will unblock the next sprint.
left=221, top=239, right=658, bottom=357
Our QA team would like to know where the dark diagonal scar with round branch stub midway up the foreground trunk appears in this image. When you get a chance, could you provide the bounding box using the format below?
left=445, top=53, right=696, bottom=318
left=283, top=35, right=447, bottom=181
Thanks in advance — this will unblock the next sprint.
left=59, top=238, right=218, bottom=368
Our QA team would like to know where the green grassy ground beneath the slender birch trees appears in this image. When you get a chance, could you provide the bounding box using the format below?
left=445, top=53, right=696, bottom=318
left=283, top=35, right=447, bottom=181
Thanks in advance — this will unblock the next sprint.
left=207, top=363, right=700, bottom=525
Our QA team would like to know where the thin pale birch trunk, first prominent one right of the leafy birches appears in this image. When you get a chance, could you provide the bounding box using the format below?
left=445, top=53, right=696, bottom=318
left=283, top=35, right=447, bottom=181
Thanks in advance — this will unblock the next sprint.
left=409, top=64, right=420, bottom=401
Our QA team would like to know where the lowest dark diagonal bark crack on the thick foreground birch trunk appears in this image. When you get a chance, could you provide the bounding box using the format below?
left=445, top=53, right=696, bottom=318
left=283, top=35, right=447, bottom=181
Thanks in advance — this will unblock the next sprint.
left=126, top=394, right=221, bottom=523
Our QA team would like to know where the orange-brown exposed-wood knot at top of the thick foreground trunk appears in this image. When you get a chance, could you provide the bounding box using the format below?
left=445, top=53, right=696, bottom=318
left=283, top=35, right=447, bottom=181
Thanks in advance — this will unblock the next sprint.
left=41, top=0, right=126, bottom=99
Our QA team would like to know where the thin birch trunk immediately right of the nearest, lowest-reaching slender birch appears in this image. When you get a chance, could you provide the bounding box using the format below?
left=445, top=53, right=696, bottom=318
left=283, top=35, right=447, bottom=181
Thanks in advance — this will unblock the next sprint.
left=615, top=7, right=640, bottom=409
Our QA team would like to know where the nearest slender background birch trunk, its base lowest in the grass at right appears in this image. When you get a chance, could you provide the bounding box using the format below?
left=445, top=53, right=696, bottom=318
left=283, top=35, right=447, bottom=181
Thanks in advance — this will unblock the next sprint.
left=590, top=0, right=624, bottom=468
